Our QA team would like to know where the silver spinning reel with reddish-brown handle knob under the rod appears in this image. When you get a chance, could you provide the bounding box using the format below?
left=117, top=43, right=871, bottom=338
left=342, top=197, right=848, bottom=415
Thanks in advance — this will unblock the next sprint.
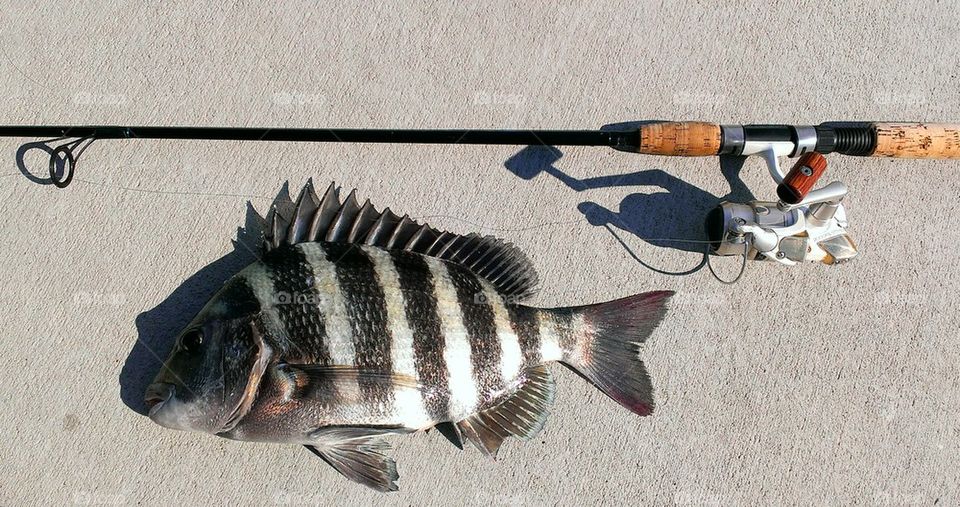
left=706, top=149, right=857, bottom=266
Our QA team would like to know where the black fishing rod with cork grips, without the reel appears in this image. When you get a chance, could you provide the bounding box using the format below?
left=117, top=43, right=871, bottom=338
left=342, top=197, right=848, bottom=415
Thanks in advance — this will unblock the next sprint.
left=0, top=122, right=960, bottom=159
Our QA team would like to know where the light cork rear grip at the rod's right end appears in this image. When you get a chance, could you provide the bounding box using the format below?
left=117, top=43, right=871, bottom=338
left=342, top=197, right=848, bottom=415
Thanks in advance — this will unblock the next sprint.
left=871, top=123, right=960, bottom=158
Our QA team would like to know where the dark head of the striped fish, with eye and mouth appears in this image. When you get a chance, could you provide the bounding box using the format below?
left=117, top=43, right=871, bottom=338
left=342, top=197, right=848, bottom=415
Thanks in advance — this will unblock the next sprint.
left=144, top=279, right=269, bottom=433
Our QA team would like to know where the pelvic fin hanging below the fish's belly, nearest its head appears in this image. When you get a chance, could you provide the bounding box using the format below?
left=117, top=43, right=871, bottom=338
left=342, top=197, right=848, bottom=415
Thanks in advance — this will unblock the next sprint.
left=304, top=427, right=412, bottom=492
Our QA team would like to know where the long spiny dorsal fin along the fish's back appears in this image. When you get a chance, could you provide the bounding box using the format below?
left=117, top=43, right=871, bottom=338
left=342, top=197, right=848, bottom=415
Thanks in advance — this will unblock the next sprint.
left=264, top=181, right=537, bottom=299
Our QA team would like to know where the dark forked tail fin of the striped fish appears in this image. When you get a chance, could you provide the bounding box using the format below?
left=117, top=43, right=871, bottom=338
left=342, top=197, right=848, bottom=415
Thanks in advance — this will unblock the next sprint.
left=563, top=291, right=673, bottom=415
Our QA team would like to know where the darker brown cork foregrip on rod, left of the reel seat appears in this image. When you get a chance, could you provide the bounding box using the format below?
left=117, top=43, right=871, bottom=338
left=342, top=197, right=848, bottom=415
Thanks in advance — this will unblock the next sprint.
left=637, top=121, right=720, bottom=157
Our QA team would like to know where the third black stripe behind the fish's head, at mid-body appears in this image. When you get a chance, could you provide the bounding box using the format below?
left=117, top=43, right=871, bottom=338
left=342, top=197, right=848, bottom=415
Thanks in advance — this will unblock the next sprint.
left=390, top=250, right=450, bottom=421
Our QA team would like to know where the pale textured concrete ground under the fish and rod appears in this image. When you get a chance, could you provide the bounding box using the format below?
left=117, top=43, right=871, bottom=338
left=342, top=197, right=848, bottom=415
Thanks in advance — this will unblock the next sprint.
left=0, top=0, right=960, bottom=505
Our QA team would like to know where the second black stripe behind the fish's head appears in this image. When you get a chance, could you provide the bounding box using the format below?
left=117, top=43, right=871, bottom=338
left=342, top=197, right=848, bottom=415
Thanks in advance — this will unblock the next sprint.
left=323, top=243, right=393, bottom=407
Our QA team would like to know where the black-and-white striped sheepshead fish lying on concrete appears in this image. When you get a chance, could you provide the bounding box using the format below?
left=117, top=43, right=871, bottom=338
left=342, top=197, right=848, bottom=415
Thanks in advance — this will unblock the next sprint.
left=145, top=183, right=672, bottom=491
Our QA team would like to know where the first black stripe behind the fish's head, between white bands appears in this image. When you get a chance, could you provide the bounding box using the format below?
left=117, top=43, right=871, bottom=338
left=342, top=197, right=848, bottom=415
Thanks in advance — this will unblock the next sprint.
left=264, top=247, right=330, bottom=364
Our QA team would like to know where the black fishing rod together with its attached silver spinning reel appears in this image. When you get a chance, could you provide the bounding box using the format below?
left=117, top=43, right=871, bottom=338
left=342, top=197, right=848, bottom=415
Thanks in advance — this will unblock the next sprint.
left=0, top=121, right=960, bottom=273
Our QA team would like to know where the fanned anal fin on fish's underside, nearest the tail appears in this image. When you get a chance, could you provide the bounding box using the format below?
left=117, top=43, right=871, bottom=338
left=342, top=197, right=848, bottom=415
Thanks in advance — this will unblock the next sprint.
left=457, top=365, right=554, bottom=457
